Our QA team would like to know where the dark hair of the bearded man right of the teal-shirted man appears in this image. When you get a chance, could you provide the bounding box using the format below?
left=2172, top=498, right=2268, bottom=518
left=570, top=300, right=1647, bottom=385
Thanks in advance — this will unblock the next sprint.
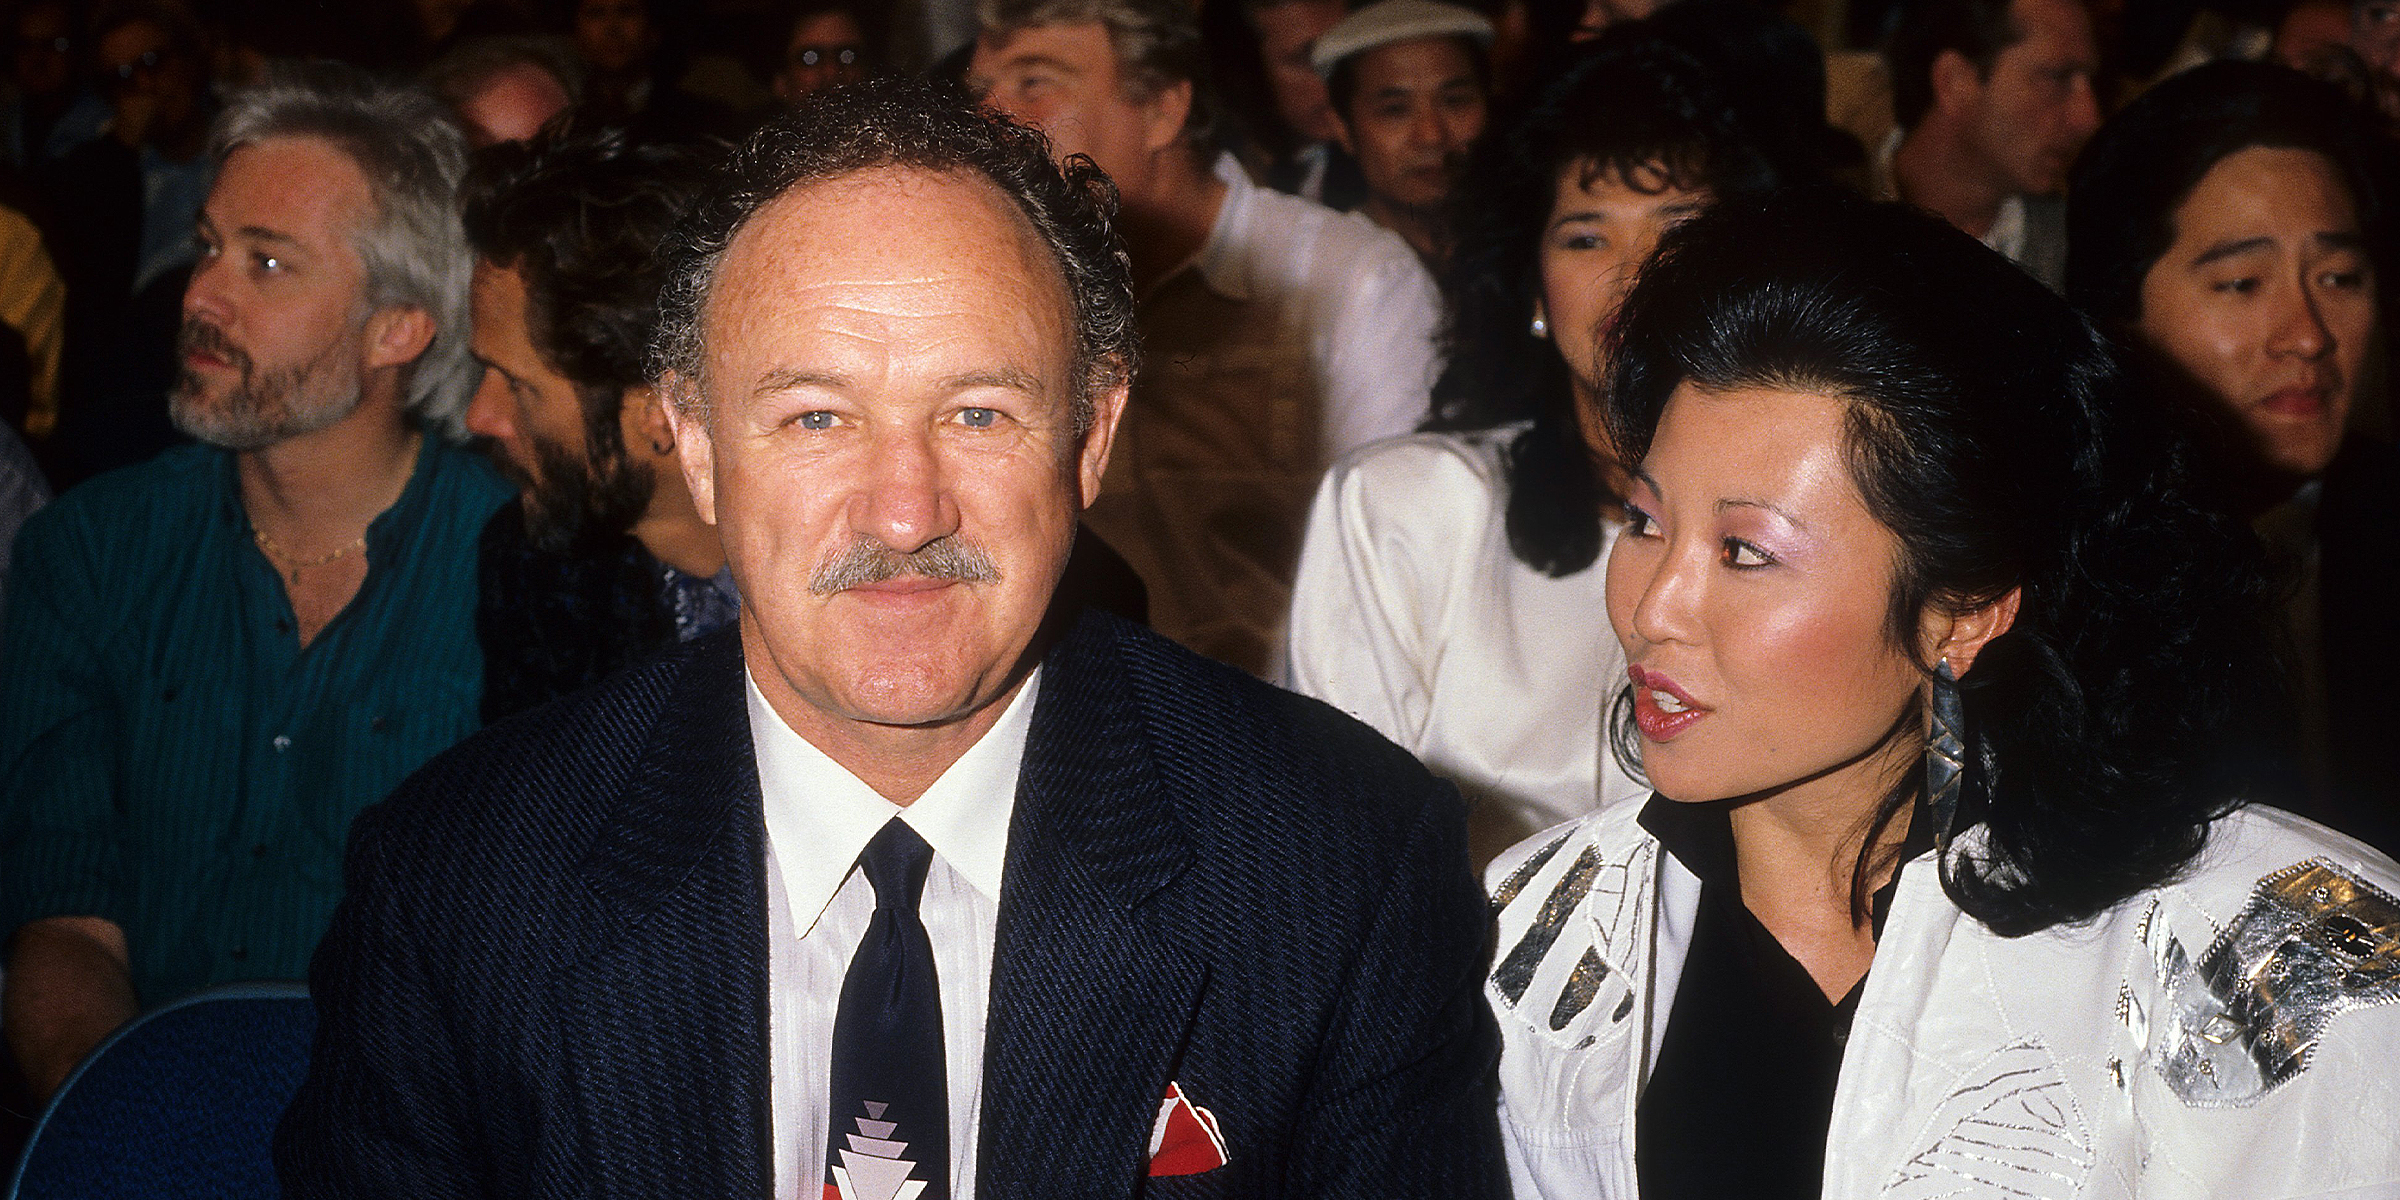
left=461, top=127, right=725, bottom=458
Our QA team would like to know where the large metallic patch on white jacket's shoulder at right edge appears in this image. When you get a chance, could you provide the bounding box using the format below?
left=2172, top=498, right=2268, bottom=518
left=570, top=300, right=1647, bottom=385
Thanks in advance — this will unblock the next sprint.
left=2148, top=859, right=2400, bottom=1106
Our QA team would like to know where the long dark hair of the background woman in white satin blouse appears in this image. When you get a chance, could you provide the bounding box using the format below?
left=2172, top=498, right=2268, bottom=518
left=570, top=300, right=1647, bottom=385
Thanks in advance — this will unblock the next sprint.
left=1423, top=35, right=1778, bottom=576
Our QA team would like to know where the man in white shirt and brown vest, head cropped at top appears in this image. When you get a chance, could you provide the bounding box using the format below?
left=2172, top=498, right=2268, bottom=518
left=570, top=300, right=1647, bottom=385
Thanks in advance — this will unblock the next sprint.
left=970, top=0, right=1440, bottom=674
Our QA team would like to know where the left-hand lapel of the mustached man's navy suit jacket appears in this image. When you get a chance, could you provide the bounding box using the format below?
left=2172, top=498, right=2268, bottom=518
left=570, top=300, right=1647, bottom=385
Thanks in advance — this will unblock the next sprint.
left=552, top=631, right=773, bottom=1195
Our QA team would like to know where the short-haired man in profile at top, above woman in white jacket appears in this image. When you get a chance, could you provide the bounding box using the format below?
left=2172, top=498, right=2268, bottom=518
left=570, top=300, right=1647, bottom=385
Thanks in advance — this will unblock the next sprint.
left=1874, top=0, right=2100, bottom=290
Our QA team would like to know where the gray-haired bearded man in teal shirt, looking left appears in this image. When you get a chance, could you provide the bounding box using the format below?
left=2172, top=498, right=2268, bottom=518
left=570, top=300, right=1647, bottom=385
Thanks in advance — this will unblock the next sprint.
left=0, top=67, right=509, bottom=1094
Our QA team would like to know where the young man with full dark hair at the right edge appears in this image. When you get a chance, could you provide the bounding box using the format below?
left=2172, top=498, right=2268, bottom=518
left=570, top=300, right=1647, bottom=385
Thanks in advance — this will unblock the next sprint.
left=2066, top=62, right=2400, bottom=852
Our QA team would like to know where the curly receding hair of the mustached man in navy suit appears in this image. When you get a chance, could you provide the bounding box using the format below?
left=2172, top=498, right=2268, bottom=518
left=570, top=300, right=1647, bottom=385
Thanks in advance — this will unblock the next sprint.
left=650, top=74, right=1140, bottom=434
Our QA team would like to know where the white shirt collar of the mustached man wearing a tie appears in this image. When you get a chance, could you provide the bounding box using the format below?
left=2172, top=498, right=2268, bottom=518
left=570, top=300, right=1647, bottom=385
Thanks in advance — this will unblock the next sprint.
left=742, top=667, right=1042, bottom=936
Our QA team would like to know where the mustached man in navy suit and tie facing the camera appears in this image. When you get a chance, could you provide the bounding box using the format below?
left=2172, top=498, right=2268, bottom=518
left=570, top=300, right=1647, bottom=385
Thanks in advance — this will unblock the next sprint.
left=276, top=82, right=1502, bottom=1200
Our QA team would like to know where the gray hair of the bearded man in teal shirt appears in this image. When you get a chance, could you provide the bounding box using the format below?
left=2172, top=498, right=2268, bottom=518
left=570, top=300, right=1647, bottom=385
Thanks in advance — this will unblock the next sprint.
left=209, top=62, right=475, bottom=439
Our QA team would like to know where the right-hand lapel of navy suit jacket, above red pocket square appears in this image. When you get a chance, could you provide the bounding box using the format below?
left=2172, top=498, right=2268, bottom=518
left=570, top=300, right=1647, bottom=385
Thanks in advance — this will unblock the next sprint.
left=977, top=617, right=1207, bottom=1200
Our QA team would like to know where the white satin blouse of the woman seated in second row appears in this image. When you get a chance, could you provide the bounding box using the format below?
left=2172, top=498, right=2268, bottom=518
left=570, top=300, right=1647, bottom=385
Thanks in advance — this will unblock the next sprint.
left=1284, top=425, right=1649, bottom=864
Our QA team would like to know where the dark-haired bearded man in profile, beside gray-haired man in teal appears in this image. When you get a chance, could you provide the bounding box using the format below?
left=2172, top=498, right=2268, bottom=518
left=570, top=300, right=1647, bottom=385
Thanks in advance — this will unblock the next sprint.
left=466, top=132, right=739, bottom=720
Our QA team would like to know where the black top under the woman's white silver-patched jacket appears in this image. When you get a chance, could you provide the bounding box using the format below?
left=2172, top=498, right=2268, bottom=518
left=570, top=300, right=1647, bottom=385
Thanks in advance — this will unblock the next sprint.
left=1634, top=794, right=1932, bottom=1200
